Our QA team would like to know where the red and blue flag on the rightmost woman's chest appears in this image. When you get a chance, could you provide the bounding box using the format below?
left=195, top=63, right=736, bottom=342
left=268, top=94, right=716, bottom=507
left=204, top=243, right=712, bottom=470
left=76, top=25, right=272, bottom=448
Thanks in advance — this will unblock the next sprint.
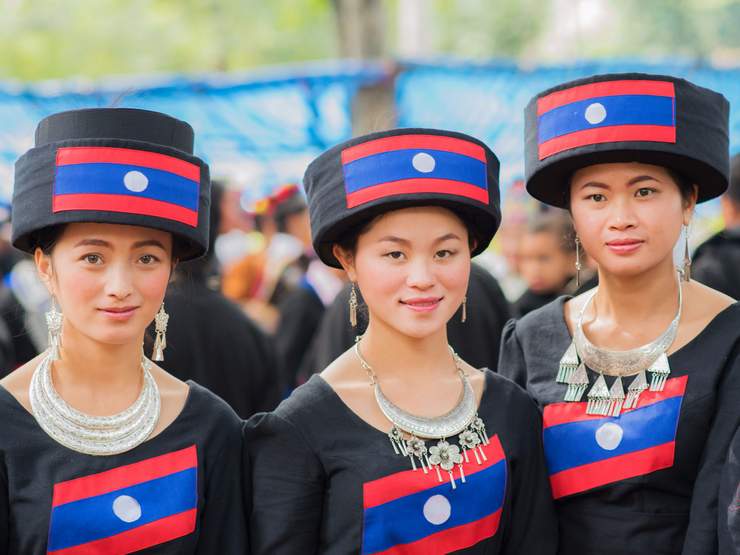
left=543, top=376, right=688, bottom=499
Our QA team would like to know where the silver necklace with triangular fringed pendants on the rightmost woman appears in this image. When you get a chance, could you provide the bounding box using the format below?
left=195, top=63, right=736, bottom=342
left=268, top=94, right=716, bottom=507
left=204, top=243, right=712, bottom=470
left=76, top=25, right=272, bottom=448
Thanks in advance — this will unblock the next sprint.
left=556, top=281, right=683, bottom=416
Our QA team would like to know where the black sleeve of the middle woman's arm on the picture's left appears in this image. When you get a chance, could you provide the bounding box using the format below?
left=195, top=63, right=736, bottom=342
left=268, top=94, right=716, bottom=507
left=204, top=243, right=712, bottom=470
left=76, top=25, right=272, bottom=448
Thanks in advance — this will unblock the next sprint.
left=244, top=414, right=324, bottom=555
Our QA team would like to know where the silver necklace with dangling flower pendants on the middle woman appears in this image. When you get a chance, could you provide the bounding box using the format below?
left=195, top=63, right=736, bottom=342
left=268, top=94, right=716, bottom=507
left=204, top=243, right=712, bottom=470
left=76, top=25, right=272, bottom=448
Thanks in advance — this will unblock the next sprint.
left=355, top=341, right=489, bottom=489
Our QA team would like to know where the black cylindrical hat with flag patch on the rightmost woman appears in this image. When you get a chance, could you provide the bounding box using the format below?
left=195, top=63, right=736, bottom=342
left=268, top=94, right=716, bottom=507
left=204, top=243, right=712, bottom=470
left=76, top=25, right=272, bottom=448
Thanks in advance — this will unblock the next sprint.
left=524, top=73, right=730, bottom=208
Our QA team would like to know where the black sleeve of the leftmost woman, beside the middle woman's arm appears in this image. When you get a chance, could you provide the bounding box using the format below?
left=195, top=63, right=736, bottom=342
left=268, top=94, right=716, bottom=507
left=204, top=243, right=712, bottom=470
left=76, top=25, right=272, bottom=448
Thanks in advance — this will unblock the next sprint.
left=195, top=422, right=249, bottom=555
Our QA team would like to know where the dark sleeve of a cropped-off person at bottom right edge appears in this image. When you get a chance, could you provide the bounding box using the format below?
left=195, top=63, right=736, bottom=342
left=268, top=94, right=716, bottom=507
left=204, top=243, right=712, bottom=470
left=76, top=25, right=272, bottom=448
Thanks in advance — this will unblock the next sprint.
left=717, top=428, right=740, bottom=555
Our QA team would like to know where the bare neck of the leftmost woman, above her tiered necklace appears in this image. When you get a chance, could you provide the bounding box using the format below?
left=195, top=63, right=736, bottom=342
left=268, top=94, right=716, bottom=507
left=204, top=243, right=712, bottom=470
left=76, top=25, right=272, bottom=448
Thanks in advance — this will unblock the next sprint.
left=54, top=326, right=143, bottom=389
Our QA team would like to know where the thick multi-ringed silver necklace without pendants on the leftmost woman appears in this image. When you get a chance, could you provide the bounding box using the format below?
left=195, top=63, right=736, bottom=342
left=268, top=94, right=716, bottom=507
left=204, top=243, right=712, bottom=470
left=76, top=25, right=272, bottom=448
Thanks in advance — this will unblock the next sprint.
left=29, top=353, right=160, bottom=456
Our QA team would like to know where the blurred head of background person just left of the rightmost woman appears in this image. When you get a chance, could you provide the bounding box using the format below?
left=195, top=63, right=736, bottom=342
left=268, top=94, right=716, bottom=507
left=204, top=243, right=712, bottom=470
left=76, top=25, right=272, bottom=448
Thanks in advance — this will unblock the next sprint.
left=513, top=209, right=576, bottom=318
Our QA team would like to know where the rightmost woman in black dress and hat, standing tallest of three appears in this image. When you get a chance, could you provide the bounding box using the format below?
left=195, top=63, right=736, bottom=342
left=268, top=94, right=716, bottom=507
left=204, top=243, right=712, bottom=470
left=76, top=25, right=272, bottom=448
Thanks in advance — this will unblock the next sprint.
left=499, top=74, right=740, bottom=555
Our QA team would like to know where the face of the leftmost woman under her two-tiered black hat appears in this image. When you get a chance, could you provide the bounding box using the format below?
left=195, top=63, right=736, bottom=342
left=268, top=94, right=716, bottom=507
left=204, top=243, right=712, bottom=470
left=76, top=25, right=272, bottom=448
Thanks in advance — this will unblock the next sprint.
left=35, top=223, right=172, bottom=345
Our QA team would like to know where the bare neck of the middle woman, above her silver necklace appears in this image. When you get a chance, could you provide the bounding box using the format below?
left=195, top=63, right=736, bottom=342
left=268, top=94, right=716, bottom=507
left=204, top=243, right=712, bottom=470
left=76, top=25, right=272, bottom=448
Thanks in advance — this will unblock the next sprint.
left=360, top=315, right=455, bottom=381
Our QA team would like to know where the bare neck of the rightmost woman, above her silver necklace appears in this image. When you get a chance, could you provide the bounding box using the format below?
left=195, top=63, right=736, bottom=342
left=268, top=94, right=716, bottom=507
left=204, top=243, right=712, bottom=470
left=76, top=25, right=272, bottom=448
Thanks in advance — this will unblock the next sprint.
left=588, top=256, right=679, bottom=326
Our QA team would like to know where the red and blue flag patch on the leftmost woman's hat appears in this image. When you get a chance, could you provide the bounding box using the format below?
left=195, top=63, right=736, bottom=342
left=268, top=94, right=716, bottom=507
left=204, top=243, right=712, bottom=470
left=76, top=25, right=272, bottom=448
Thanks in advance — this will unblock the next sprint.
left=52, top=147, right=200, bottom=227
